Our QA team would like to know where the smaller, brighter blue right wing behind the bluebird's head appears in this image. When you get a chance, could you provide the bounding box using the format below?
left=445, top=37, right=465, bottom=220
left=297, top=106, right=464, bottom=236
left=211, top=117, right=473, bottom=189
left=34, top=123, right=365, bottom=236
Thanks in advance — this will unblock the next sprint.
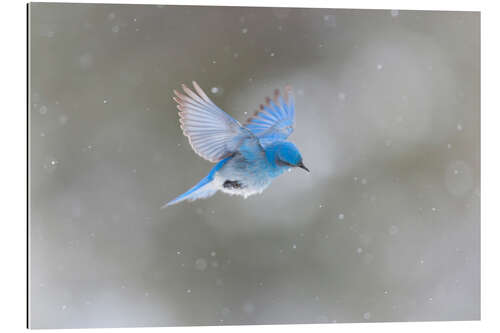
left=244, top=86, right=295, bottom=146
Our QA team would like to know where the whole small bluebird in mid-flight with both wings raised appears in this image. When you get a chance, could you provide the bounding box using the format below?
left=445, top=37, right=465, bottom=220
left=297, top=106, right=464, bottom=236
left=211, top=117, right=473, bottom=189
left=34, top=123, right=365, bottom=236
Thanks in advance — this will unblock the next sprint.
left=162, top=82, right=309, bottom=208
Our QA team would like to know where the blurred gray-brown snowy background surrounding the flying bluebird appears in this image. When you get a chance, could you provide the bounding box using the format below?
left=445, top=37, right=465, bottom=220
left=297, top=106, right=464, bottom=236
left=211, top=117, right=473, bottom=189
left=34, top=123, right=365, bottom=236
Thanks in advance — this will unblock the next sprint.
left=29, top=3, right=480, bottom=328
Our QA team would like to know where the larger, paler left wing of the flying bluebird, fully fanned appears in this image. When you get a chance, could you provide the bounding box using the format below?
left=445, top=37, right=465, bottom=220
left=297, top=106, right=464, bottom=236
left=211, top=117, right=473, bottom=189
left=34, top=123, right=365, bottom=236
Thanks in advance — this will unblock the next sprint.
left=173, top=81, right=258, bottom=162
